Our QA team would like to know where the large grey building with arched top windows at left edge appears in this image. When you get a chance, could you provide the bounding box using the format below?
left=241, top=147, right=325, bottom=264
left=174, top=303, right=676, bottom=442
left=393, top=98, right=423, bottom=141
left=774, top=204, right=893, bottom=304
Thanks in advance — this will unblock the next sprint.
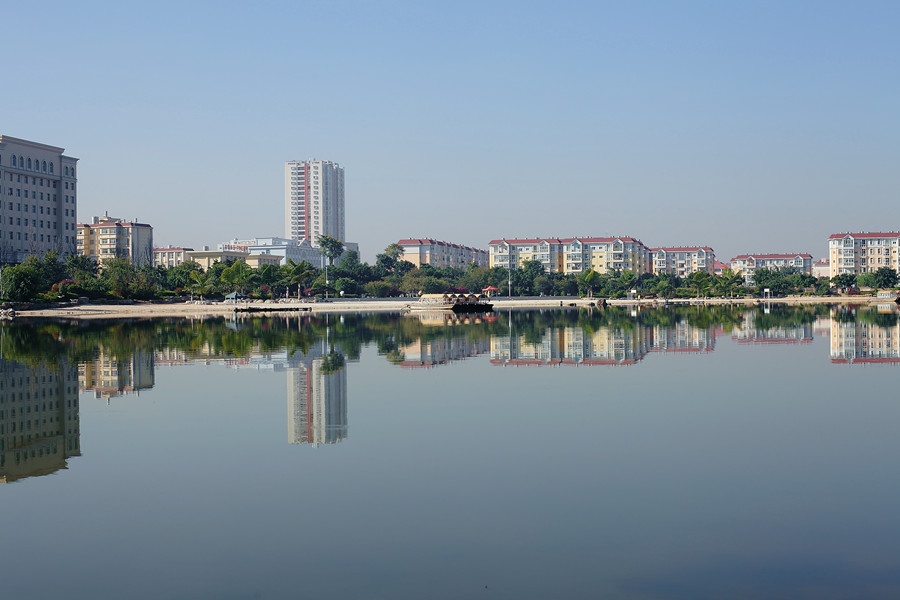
left=0, top=135, right=78, bottom=264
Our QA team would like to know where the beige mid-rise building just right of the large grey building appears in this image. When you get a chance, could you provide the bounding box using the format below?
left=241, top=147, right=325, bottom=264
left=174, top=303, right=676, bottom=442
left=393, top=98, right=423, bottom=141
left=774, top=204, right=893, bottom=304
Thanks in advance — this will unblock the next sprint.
left=76, top=214, right=153, bottom=267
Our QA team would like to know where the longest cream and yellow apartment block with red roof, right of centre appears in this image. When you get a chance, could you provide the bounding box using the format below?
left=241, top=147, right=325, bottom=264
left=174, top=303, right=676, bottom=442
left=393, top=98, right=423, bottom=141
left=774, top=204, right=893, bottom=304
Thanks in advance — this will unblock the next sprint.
left=488, top=237, right=650, bottom=274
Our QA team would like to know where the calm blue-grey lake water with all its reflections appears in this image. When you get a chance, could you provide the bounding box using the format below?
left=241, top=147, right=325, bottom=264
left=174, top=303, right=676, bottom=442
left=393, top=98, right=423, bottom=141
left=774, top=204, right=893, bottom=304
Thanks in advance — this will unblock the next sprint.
left=0, top=307, right=900, bottom=599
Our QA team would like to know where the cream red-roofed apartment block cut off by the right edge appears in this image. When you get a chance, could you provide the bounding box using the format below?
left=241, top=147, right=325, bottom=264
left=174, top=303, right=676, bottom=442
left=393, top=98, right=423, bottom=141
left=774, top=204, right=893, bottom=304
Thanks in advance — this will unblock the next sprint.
left=828, top=232, right=900, bottom=277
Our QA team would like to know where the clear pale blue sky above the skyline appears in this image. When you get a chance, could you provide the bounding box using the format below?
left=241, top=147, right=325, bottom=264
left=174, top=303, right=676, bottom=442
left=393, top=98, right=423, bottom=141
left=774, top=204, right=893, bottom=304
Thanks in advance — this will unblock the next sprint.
left=0, top=0, right=900, bottom=262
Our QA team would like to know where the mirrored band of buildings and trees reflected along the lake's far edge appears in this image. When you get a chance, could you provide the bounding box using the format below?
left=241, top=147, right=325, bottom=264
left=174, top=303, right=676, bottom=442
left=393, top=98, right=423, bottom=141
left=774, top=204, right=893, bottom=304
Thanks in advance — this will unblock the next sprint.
left=0, top=305, right=900, bottom=481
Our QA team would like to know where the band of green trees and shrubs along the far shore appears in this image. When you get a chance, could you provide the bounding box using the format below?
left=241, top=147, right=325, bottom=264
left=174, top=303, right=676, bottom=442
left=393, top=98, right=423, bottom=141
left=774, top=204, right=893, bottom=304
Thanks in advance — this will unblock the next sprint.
left=0, top=244, right=897, bottom=302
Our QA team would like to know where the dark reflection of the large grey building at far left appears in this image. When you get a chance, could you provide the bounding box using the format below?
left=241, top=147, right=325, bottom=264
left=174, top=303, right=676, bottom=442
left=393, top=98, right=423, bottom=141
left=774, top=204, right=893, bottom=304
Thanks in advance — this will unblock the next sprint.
left=0, top=359, right=81, bottom=483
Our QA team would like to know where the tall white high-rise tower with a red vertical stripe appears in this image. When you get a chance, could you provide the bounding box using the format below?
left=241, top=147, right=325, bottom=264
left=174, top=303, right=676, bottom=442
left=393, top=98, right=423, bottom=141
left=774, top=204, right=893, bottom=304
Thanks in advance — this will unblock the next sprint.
left=284, top=159, right=345, bottom=247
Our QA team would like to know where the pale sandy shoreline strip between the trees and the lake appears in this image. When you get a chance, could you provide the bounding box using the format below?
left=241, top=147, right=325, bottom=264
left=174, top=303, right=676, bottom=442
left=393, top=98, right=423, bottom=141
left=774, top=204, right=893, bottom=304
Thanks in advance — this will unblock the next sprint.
left=5, top=296, right=894, bottom=319
